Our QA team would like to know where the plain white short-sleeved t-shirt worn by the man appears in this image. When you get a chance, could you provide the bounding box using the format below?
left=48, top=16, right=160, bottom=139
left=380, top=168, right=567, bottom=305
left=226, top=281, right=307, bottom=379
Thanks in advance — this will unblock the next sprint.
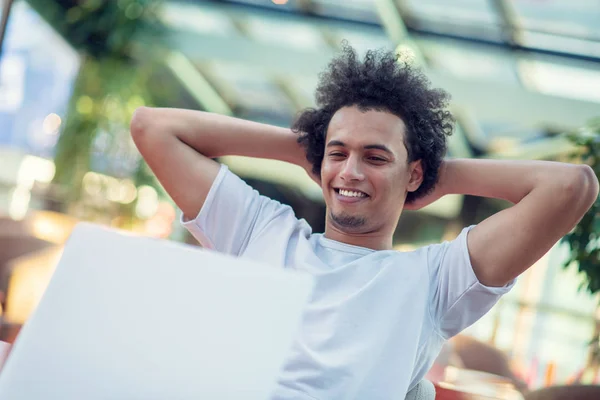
left=184, top=166, right=514, bottom=400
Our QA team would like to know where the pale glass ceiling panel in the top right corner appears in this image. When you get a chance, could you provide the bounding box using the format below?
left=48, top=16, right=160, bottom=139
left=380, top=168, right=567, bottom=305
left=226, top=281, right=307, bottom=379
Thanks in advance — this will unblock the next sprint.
left=511, top=0, right=600, bottom=40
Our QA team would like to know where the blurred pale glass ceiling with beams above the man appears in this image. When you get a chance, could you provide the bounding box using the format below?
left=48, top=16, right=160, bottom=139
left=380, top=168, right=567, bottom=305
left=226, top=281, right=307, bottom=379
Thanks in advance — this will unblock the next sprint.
left=148, top=0, right=600, bottom=215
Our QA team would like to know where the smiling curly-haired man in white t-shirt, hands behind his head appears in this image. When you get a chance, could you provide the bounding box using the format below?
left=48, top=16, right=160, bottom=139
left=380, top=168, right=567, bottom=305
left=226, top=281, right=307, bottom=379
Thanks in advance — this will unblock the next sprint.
left=131, top=46, right=598, bottom=400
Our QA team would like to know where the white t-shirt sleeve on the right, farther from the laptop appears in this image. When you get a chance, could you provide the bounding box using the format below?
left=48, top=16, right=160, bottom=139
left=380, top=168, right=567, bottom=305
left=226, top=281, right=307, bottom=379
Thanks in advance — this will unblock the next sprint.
left=428, top=226, right=515, bottom=339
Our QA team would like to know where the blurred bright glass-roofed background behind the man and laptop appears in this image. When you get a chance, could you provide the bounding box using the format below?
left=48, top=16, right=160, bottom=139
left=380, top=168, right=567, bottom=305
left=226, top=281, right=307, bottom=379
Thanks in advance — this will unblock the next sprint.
left=0, top=0, right=600, bottom=396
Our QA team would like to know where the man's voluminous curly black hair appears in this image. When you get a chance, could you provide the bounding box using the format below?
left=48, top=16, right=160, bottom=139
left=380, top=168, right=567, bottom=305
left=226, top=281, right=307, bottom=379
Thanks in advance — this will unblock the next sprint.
left=292, top=42, right=454, bottom=202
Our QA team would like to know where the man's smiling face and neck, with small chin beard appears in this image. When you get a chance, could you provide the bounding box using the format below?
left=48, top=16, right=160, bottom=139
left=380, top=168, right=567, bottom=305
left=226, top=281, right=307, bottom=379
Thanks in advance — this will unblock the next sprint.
left=321, top=106, right=423, bottom=248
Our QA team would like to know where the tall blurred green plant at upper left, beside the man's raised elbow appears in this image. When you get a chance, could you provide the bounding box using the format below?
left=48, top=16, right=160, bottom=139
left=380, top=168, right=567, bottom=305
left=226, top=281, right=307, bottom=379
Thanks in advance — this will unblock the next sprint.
left=27, top=0, right=165, bottom=217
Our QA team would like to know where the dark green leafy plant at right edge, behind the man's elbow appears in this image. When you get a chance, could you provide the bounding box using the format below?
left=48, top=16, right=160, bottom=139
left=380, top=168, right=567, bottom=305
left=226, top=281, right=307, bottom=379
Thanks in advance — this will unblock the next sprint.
left=563, top=118, right=600, bottom=294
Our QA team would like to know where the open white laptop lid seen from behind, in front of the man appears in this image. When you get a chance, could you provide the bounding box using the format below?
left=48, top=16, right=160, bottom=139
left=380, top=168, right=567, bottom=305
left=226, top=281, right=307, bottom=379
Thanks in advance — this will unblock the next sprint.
left=0, top=223, right=313, bottom=400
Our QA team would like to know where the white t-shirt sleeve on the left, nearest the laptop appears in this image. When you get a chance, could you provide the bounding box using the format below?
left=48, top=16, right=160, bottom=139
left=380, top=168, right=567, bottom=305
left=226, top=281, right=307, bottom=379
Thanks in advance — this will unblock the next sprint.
left=181, top=165, right=289, bottom=256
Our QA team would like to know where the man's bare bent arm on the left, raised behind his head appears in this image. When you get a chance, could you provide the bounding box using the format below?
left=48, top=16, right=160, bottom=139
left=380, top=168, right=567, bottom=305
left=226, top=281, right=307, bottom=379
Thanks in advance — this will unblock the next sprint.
left=131, top=107, right=310, bottom=218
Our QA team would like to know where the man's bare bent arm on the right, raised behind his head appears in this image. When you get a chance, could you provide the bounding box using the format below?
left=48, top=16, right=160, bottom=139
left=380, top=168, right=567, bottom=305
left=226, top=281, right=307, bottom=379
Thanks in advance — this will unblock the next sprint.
left=435, top=159, right=598, bottom=287
